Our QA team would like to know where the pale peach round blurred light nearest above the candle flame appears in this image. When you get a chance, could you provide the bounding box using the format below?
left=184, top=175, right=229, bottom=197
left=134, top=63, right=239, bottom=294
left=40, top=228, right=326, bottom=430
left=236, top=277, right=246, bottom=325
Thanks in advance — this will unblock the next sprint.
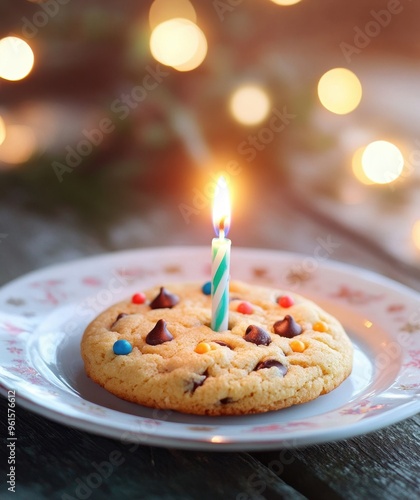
left=230, top=85, right=270, bottom=125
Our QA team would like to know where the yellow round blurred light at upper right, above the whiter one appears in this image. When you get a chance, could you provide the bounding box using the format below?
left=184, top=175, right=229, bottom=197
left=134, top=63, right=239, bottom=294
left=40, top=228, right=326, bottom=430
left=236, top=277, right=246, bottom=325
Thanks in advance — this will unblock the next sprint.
left=318, top=68, right=362, bottom=115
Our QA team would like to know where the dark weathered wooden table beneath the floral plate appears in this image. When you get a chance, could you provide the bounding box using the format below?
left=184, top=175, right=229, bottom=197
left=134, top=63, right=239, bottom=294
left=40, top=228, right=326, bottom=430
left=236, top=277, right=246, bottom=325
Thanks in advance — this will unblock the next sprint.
left=0, top=188, right=420, bottom=500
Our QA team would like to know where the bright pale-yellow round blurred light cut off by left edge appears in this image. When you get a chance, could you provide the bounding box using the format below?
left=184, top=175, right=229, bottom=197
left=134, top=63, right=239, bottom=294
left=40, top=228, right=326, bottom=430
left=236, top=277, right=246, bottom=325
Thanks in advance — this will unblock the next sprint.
left=0, top=36, right=34, bottom=81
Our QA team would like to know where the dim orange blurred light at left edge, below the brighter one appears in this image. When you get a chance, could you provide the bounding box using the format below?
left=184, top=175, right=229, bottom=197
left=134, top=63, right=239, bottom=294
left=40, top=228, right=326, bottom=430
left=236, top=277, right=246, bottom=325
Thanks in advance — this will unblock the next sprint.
left=0, top=125, right=37, bottom=169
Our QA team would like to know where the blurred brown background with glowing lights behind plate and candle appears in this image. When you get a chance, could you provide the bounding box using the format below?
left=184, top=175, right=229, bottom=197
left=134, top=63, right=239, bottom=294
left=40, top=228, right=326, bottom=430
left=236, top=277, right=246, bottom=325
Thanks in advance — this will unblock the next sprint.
left=0, top=0, right=420, bottom=282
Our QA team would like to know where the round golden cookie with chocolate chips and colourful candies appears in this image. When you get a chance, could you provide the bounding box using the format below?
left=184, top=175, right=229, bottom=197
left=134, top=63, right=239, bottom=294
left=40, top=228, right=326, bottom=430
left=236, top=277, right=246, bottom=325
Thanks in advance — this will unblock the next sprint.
left=81, top=282, right=353, bottom=415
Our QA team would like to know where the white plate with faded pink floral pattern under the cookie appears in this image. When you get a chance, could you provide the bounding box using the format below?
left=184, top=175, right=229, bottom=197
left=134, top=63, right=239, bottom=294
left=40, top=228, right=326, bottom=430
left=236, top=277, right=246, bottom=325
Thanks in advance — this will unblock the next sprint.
left=0, top=247, right=420, bottom=451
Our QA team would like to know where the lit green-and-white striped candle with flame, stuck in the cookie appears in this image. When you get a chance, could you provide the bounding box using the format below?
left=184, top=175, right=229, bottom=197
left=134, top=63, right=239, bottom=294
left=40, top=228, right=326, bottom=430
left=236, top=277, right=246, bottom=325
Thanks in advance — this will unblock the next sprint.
left=211, top=177, right=231, bottom=332
